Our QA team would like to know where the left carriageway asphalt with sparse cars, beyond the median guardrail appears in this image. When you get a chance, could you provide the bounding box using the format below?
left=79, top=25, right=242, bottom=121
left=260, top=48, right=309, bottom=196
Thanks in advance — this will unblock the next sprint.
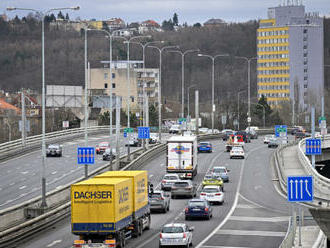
left=0, top=134, right=136, bottom=210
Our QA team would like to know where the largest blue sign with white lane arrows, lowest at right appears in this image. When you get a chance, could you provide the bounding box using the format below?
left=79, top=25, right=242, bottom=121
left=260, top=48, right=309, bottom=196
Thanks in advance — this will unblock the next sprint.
left=287, top=176, right=313, bottom=202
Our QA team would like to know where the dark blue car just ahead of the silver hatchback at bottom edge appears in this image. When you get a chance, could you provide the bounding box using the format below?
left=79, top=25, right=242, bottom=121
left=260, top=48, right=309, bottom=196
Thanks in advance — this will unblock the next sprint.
left=184, top=199, right=212, bottom=220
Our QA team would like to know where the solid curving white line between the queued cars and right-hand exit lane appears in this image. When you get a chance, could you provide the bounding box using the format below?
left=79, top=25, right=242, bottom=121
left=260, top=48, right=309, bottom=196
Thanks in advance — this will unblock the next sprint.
left=196, top=146, right=263, bottom=248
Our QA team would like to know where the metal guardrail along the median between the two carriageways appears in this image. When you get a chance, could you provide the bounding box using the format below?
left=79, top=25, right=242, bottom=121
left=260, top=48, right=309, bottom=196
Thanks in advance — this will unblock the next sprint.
left=0, top=134, right=221, bottom=248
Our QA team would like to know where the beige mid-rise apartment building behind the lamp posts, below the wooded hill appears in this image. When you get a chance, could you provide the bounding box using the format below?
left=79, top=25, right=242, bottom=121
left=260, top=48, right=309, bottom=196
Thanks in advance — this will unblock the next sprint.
left=89, top=61, right=159, bottom=113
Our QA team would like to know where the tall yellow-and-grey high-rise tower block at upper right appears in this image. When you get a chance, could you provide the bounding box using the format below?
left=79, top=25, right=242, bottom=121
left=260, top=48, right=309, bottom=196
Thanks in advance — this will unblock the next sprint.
left=257, top=1, right=324, bottom=110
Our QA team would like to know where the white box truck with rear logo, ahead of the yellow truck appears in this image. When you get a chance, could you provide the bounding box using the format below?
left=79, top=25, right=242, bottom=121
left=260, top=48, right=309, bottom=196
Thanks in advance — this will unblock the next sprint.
left=166, top=136, right=198, bottom=179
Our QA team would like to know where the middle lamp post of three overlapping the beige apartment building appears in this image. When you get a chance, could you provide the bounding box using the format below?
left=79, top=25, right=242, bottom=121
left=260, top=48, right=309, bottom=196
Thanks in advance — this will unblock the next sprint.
left=123, top=35, right=151, bottom=161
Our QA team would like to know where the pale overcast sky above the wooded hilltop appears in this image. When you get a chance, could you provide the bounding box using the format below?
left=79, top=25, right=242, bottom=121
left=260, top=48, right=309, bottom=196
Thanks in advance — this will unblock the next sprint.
left=0, top=0, right=330, bottom=24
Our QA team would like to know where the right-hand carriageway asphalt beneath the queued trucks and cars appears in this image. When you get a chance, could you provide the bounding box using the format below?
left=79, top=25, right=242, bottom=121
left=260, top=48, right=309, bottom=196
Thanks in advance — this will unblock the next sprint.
left=17, top=137, right=291, bottom=248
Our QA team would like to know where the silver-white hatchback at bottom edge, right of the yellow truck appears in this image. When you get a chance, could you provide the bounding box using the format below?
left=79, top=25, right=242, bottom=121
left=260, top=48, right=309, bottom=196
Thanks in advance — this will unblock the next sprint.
left=159, top=223, right=194, bottom=248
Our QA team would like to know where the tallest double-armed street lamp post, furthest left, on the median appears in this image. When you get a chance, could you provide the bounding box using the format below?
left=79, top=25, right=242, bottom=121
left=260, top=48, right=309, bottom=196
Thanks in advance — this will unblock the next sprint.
left=7, top=6, right=80, bottom=208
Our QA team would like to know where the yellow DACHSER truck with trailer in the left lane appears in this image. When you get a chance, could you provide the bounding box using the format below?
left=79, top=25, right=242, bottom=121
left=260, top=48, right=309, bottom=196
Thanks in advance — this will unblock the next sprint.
left=71, top=171, right=151, bottom=247
